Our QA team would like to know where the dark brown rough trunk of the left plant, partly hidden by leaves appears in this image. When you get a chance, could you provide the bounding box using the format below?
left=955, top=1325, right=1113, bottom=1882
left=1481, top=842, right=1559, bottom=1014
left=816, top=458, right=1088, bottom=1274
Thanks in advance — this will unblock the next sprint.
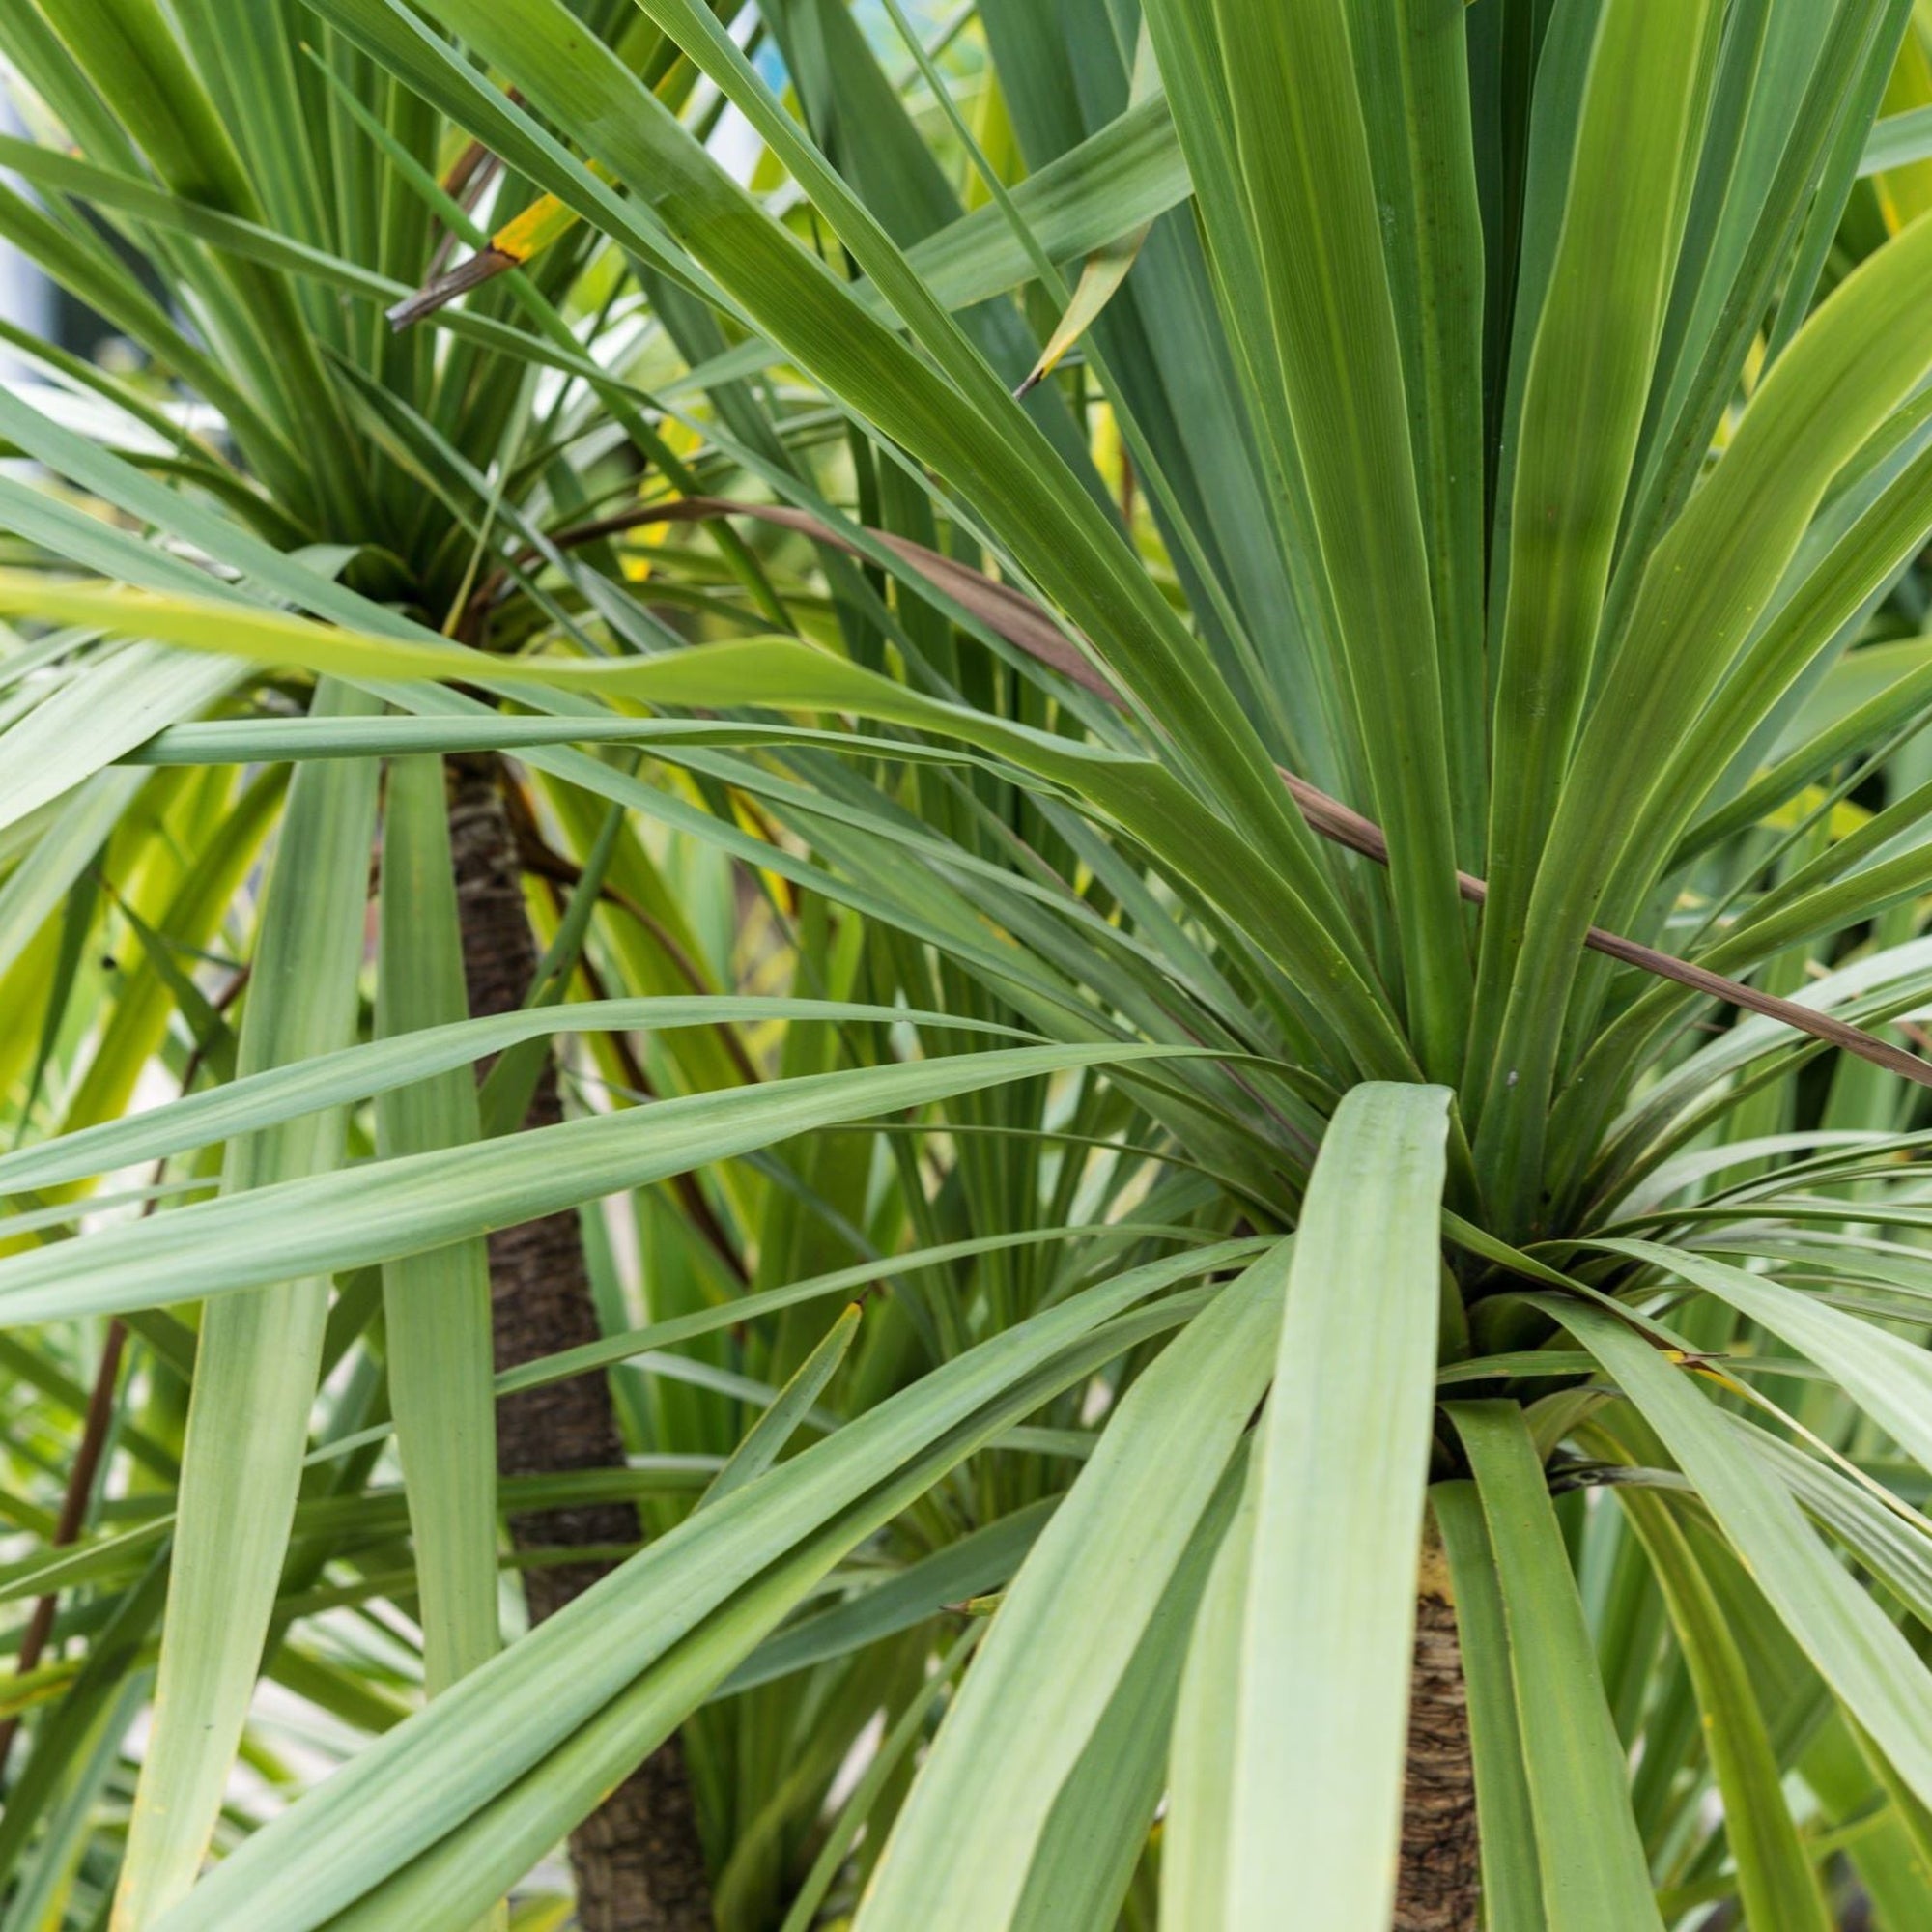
left=450, top=757, right=711, bottom=1932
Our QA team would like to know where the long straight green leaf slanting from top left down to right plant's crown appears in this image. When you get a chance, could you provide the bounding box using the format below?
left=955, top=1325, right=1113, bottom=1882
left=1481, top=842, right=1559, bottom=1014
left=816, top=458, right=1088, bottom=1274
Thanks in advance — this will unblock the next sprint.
left=359, top=0, right=1406, bottom=1074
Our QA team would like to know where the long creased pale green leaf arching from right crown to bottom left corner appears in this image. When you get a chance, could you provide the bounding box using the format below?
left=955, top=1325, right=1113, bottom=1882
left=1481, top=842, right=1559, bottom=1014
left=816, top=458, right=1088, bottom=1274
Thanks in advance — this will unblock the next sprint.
left=155, top=1244, right=1252, bottom=1932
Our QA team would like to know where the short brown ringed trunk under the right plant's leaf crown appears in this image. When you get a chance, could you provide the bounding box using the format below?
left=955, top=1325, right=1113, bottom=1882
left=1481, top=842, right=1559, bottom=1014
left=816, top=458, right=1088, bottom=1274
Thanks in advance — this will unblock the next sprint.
left=1393, top=1582, right=1480, bottom=1932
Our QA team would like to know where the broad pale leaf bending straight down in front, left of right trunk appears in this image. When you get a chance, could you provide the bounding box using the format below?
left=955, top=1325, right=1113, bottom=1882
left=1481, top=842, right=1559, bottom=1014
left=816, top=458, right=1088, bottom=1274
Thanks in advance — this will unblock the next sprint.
left=1184, top=1086, right=1449, bottom=1932
